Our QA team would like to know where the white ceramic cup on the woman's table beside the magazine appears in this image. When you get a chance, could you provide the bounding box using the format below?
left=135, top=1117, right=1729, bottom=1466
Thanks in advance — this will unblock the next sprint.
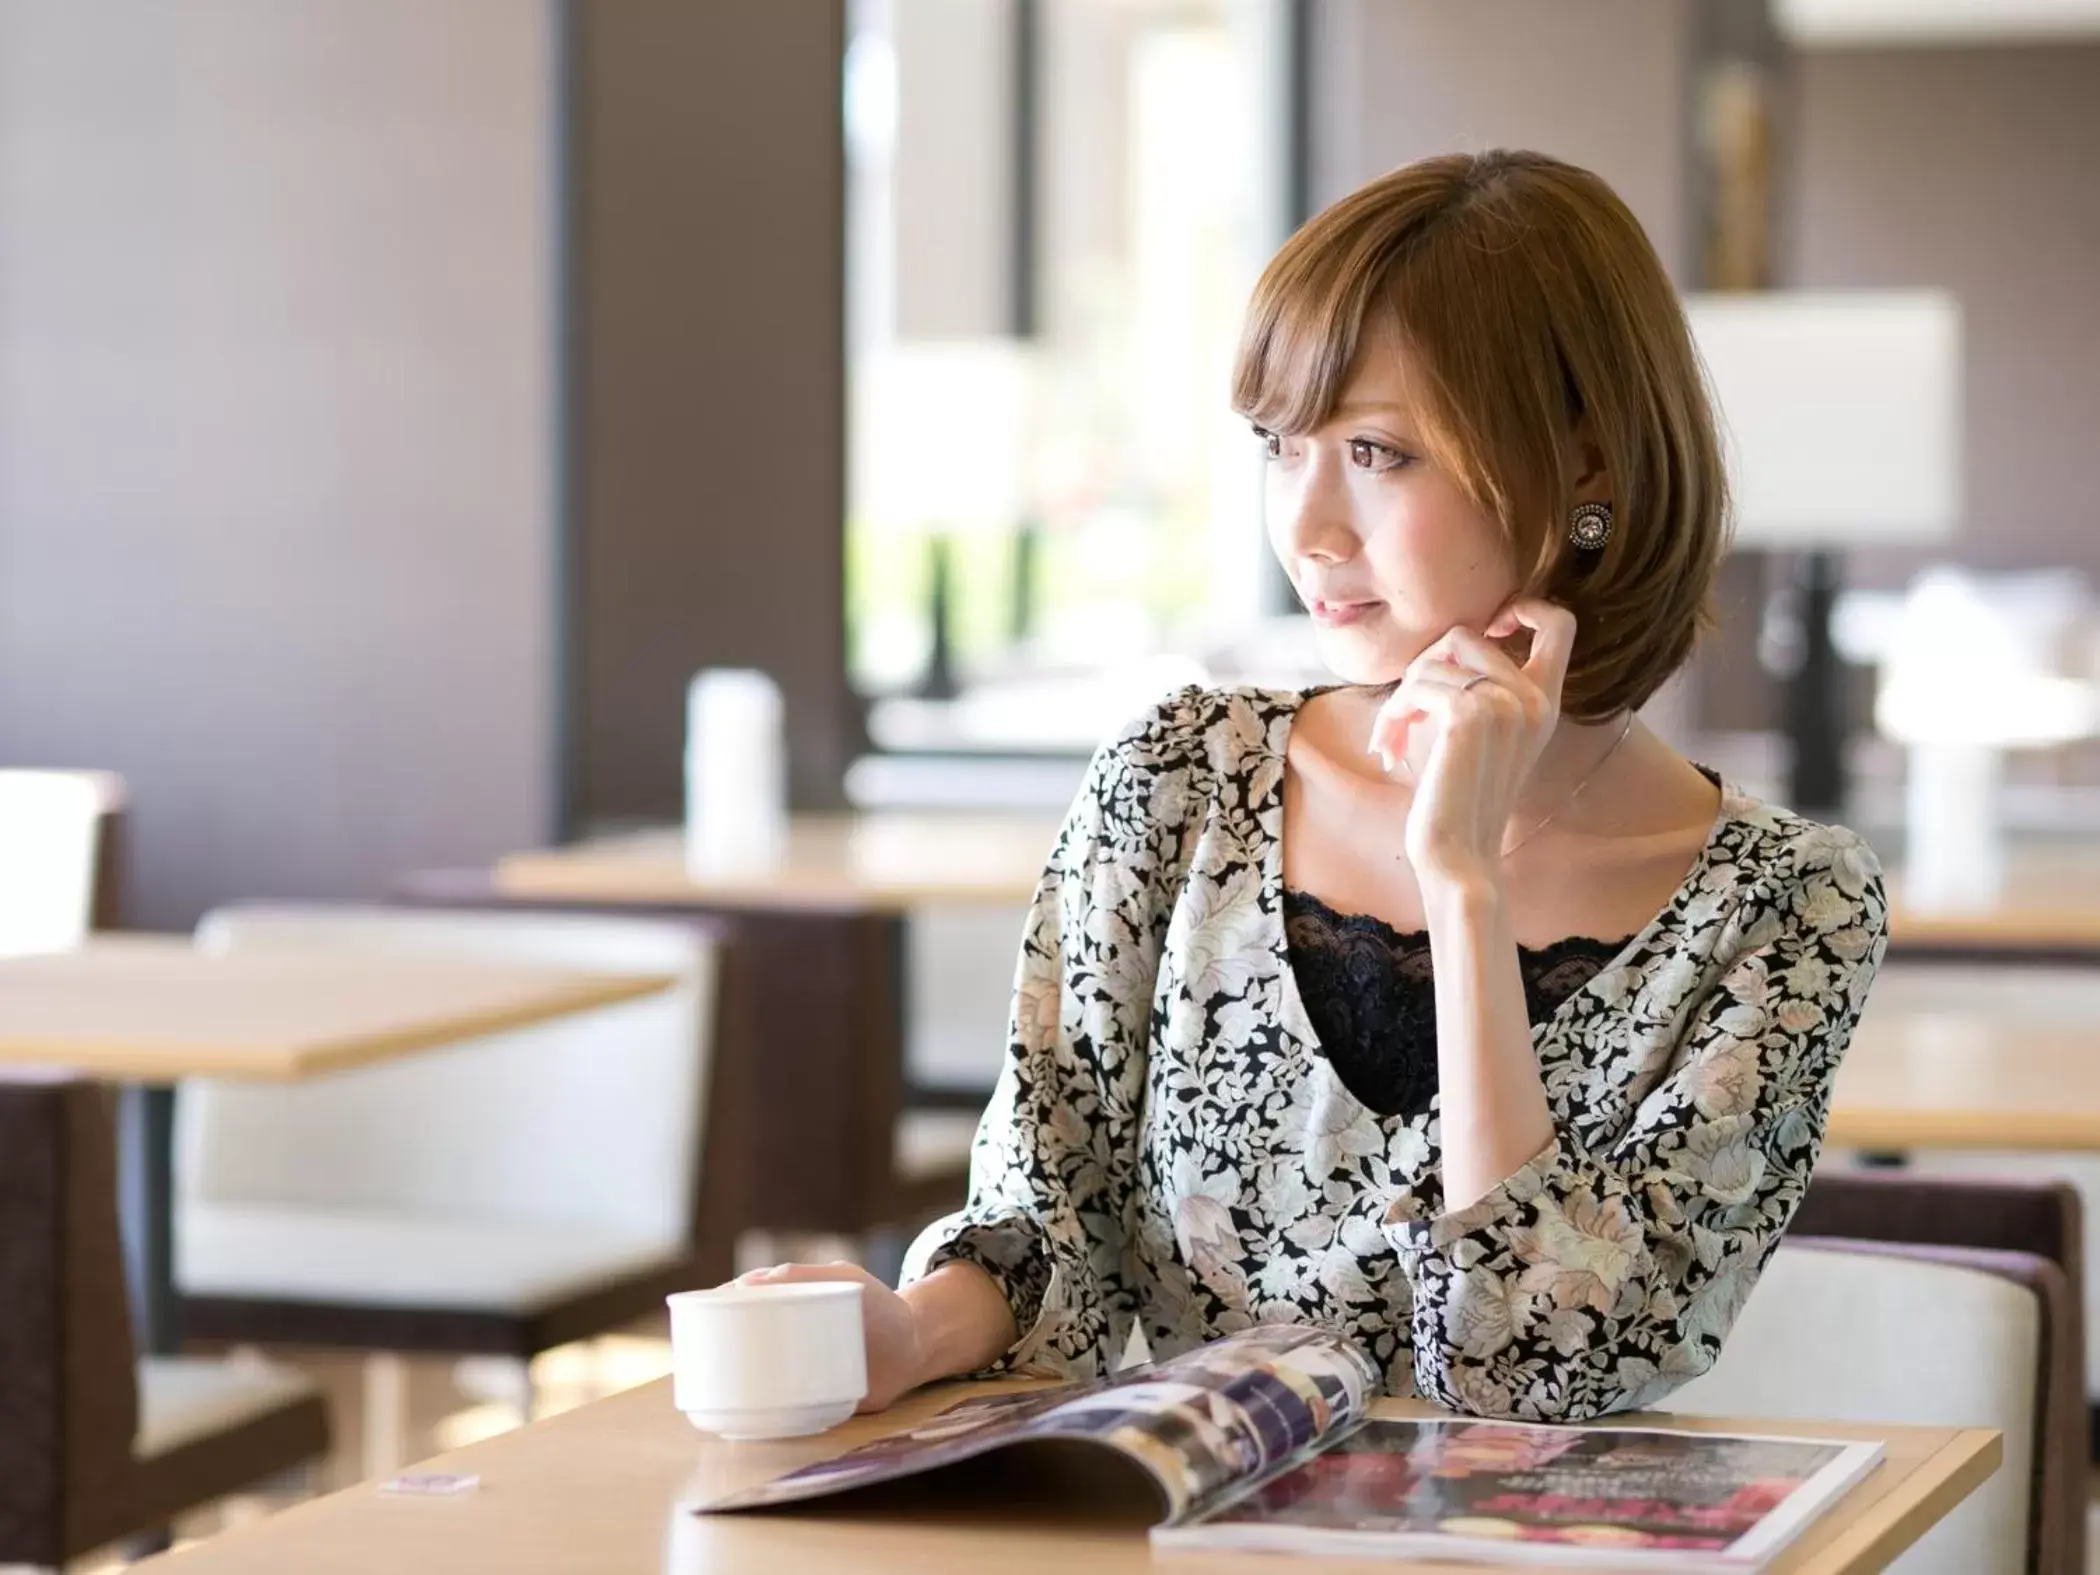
left=664, top=1279, right=867, bottom=1439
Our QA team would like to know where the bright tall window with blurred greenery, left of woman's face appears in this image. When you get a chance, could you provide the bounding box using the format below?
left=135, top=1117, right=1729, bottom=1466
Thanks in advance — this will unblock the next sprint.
left=846, top=0, right=1289, bottom=741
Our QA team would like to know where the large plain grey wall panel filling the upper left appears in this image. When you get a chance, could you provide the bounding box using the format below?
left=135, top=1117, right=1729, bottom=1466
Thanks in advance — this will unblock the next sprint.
left=0, top=0, right=554, bottom=926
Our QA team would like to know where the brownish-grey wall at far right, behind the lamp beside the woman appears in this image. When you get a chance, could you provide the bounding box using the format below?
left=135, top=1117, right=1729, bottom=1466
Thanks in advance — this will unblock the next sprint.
left=1787, top=44, right=2100, bottom=582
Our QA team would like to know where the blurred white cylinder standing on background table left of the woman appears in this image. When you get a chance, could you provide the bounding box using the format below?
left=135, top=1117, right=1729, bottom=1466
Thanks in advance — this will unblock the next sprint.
left=685, top=668, right=788, bottom=874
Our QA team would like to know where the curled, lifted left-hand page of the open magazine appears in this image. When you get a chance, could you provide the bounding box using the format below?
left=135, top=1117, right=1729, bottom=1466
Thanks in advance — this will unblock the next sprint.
left=704, top=1323, right=1378, bottom=1520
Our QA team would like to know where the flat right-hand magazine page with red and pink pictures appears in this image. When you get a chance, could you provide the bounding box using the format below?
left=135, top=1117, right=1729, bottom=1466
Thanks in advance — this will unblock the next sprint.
left=1153, top=1418, right=1882, bottom=1569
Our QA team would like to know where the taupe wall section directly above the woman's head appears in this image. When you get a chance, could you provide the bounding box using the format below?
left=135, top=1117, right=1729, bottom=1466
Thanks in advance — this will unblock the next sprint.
left=1313, top=0, right=1691, bottom=277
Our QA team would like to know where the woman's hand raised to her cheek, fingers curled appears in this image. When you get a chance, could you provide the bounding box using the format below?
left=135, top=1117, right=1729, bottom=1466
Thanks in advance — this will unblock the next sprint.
left=1371, top=599, right=1575, bottom=890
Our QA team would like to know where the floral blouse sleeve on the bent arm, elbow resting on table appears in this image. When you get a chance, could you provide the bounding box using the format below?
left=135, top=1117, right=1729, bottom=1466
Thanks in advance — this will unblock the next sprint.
left=1386, top=827, right=1888, bottom=1420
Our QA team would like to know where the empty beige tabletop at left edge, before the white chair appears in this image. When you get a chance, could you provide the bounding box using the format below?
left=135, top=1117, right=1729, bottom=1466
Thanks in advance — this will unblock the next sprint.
left=0, top=935, right=672, bottom=1084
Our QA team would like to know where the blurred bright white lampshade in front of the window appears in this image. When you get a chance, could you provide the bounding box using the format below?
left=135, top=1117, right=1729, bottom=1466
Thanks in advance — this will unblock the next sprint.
left=851, top=338, right=1033, bottom=531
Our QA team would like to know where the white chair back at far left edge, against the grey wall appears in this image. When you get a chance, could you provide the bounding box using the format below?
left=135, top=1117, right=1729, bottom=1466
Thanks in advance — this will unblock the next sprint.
left=0, top=771, right=124, bottom=958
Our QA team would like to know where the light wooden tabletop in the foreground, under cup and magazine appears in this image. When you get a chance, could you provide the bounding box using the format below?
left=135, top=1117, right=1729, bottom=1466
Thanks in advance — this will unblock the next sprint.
left=155, top=1380, right=2001, bottom=1575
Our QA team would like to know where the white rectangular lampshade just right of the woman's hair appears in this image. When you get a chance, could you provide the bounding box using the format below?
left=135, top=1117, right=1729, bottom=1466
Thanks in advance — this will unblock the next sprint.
left=1684, top=290, right=1961, bottom=548
